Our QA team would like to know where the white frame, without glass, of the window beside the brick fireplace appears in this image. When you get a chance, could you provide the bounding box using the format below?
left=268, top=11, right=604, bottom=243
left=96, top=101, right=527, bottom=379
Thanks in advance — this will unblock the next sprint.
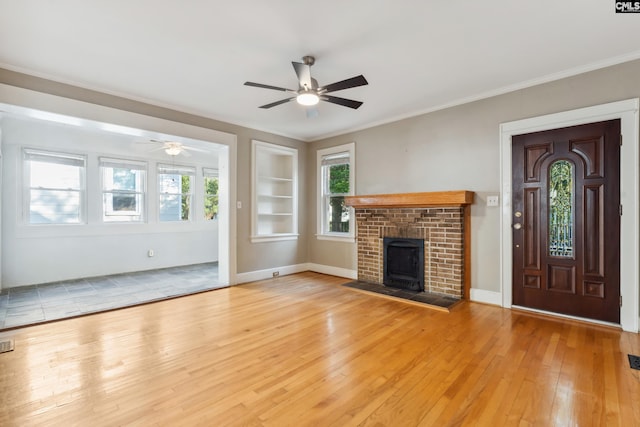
left=316, top=142, right=356, bottom=242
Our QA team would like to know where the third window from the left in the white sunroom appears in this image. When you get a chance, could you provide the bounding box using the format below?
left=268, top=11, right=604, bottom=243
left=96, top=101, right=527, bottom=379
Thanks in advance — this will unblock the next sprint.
left=158, top=164, right=196, bottom=221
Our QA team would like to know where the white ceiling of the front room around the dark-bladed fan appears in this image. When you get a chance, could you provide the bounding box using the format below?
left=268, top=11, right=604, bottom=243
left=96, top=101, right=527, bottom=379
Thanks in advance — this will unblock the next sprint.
left=0, top=0, right=640, bottom=140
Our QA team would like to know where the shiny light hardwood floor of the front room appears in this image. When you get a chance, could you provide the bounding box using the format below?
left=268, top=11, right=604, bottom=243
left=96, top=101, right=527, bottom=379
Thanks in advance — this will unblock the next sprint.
left=0, top=273, right=640, bottom=427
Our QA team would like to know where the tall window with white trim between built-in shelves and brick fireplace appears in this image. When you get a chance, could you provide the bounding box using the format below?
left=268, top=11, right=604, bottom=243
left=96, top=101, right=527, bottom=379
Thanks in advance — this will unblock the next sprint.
left=318, top=143, right=355, bottom=239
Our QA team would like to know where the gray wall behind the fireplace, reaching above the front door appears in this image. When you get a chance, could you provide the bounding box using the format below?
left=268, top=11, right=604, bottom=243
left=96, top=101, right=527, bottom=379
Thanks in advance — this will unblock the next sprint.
left=307, top=61, right=640, bottom=292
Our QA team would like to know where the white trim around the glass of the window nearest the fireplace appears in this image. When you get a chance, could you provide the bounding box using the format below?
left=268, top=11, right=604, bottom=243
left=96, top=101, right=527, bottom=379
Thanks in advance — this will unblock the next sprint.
left=316, top=142, right=356, bottom=243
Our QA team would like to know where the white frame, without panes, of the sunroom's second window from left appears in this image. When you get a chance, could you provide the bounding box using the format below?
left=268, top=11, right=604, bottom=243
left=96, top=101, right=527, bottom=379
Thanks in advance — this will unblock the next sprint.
left=98, top=157, right=149, bottom=224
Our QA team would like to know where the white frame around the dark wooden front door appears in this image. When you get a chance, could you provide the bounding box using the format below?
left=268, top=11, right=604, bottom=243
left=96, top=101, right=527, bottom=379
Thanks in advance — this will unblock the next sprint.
left=500, top=98, right=640, bottom=332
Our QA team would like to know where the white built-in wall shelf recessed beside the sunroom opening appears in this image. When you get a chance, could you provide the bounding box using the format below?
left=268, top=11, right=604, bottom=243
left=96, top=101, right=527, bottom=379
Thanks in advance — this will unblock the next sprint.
left=251, top=140, right=298, bottom=242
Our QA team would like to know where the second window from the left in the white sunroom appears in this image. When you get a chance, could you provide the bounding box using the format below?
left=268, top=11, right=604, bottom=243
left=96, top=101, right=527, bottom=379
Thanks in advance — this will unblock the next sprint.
left=100, top=157, right=147, bottom=222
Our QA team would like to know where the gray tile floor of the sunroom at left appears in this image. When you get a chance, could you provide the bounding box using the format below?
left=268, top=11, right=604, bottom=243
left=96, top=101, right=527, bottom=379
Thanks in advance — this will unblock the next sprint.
left=0, top=263, right=224, bottom=330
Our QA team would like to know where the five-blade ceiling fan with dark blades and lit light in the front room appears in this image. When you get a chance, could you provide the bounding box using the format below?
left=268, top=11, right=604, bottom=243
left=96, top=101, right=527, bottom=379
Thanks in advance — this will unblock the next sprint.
left=244, top=55, right=369, bottom=109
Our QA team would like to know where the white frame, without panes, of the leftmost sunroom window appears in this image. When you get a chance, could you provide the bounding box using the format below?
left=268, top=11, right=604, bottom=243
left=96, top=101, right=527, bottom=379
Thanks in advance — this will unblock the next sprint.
left=22, top=148, right=87, bottom=227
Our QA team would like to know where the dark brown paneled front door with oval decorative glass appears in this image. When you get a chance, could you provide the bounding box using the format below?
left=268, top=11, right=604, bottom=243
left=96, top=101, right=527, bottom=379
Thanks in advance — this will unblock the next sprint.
left=512, top=120, right=620, bottom=323
